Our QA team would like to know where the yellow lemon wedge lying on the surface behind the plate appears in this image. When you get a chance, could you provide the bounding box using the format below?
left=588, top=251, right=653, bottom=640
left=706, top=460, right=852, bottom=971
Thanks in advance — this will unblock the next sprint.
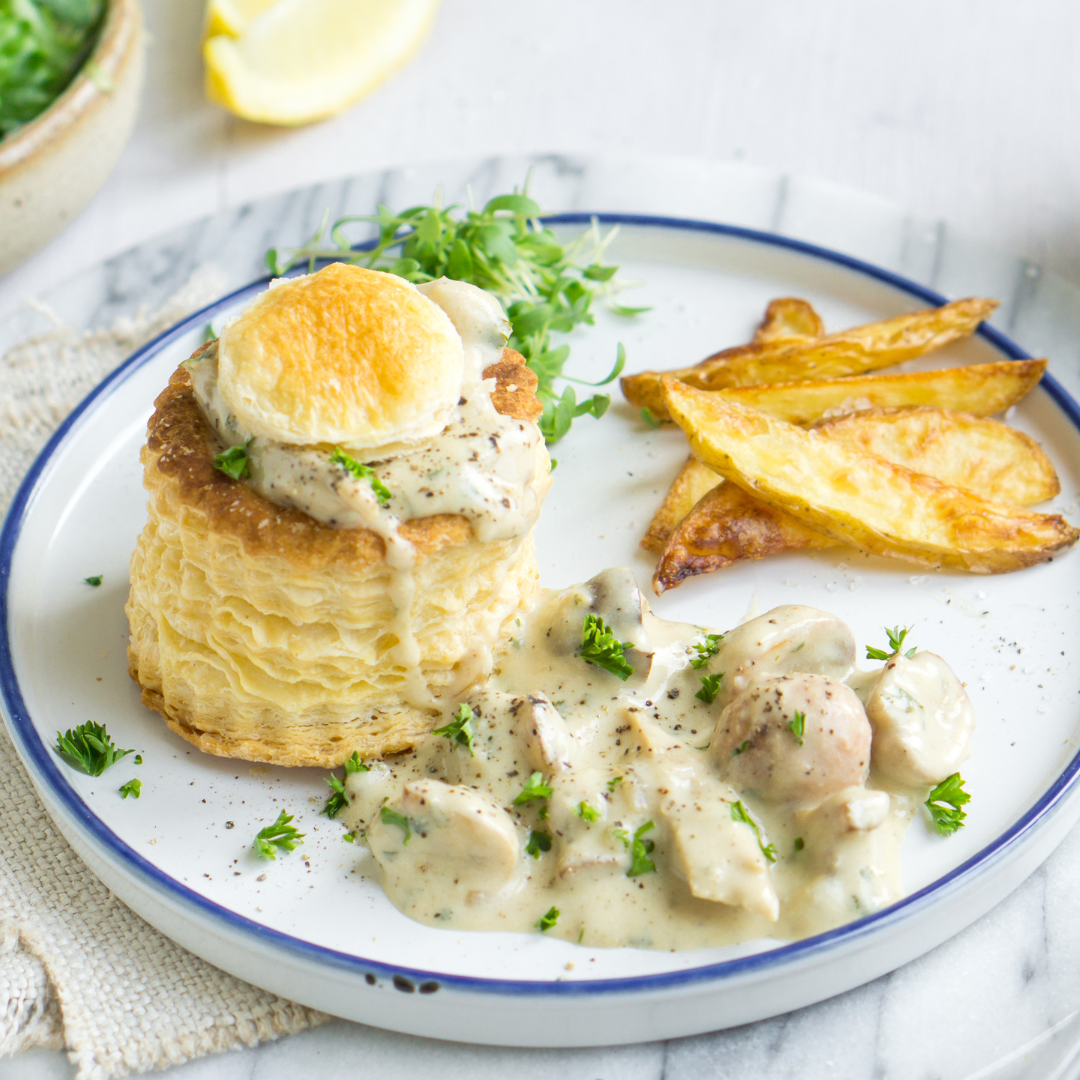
left=203, top=0, right=438, bottom=124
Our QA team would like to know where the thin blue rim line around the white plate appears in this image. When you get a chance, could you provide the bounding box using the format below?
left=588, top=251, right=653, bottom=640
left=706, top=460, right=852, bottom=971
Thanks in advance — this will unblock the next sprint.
left=0, top=213, right=1080, bottom=997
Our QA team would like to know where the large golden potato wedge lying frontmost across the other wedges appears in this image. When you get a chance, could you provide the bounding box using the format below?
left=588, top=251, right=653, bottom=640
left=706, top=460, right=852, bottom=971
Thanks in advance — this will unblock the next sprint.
left=662, top=376, right=1080, bottom=573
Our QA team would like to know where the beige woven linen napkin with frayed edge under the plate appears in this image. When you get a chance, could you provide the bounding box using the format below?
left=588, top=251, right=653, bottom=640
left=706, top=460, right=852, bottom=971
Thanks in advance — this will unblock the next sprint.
left=0, top=269, right=326, bottom=1080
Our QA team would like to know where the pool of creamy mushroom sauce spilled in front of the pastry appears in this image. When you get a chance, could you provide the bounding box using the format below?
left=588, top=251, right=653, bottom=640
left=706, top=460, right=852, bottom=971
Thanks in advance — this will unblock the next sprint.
left=340, top=570, right=970, bottom=949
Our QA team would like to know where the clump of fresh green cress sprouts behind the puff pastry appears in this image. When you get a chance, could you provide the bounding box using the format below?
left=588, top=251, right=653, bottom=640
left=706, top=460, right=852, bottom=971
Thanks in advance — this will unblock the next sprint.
left=267, top=183, right=647, bottom=443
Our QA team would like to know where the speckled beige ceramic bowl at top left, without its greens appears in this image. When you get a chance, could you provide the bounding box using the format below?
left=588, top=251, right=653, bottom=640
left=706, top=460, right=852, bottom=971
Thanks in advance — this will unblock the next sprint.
left=0, top=0, right=144, bottom=273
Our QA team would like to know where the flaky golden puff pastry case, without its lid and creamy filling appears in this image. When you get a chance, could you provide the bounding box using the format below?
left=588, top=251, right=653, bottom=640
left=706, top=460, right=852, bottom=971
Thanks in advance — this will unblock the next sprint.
left=127, top=350, right=539, bottom=767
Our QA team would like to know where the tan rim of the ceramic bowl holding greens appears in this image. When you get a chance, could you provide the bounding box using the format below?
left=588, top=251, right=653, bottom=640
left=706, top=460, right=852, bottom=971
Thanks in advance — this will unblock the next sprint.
left=0, top=0, right=143, bottom=177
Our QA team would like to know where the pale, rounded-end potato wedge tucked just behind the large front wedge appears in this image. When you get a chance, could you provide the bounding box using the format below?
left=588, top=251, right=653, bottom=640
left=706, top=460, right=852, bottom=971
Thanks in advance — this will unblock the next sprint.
left=813, top=406, right=1062, bottom=507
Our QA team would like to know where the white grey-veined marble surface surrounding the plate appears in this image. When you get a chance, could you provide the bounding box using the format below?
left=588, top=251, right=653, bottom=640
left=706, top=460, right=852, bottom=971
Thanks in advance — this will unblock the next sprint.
left=6, top=0, right=1080, bottom=1080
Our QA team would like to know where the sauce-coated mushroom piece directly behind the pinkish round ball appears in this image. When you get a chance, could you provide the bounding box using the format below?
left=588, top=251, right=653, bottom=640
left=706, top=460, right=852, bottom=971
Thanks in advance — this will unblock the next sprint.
left=712, top=604, right=855, bottom=710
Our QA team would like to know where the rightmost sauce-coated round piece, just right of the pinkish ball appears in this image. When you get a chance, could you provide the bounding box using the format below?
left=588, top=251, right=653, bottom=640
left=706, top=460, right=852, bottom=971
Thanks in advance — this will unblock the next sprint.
left=866, top=652, right=975, bottom=787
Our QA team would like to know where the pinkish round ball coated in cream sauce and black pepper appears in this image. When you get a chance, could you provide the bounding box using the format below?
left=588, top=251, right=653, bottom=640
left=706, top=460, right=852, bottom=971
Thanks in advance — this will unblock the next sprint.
left=710, top=675, right=870, bottom=805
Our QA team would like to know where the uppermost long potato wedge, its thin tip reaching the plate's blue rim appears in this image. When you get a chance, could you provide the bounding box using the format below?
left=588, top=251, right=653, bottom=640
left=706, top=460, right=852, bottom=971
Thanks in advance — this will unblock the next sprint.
left=620, top=297, right=998, bottom=419
